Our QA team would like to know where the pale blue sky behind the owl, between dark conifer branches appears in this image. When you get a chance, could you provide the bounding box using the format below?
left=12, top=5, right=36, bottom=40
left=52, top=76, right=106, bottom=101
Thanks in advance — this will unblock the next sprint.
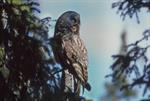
left=38, top=0, right=150, bottom=101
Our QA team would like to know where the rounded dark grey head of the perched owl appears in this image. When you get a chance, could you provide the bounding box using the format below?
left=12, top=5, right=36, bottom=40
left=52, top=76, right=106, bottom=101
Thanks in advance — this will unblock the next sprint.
left=54, top=11, right=80, bottom=36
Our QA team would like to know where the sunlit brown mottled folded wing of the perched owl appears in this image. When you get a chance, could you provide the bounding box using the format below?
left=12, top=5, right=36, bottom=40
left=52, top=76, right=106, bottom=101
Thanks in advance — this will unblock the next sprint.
left=62, top=35, right=88, bottom=86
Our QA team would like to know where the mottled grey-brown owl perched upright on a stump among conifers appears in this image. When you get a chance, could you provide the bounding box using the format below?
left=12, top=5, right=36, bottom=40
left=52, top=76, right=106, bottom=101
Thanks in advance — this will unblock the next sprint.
left=53, top=11, right=91, bottom=92
